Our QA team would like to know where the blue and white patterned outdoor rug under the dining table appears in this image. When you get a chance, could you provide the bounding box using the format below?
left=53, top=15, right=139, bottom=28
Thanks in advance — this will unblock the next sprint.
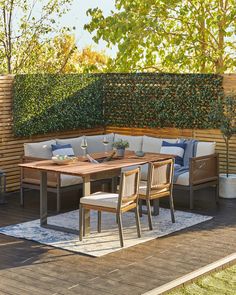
left=0, top=208, right=212, bottom=257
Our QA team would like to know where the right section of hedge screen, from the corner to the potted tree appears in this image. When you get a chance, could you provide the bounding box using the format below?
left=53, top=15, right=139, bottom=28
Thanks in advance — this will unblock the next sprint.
left=104, top=73, right=223, bottom=128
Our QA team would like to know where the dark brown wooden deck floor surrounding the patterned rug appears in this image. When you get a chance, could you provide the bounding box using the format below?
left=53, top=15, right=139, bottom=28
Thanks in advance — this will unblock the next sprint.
left=0, top=189, right=236, bottom=295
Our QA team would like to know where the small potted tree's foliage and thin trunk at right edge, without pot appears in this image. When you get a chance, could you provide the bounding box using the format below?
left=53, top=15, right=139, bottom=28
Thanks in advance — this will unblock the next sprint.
left=210, top=94, right=236, bottom=177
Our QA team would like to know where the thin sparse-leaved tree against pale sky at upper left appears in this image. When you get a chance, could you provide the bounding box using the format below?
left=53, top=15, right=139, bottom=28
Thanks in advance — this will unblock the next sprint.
left=0, top=0, right=72, bottom=74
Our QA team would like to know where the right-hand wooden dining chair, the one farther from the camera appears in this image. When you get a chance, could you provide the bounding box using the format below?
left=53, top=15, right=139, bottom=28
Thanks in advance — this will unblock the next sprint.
left=139, top=159, right=175, bottom=230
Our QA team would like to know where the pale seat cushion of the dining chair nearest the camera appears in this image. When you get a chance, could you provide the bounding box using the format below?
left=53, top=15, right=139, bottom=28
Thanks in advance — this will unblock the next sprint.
left=80, top=192, right=119, bottom=209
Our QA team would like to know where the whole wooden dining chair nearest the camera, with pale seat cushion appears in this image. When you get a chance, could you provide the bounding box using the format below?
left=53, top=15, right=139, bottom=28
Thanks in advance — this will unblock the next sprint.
left=79, top=168, right=141, bottom=247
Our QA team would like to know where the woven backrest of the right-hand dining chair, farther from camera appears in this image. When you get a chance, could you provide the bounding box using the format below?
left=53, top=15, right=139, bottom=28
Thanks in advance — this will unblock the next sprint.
left=147, top=159, right=174, bottom=194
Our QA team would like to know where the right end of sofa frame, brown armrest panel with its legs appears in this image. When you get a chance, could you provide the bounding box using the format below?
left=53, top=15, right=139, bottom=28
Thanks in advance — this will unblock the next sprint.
left=174, top=154, right=219, bottom=210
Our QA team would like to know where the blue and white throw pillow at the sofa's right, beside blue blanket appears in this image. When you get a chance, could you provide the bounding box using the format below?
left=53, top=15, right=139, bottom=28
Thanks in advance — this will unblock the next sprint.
left=160, top=141, right=186, bottom=166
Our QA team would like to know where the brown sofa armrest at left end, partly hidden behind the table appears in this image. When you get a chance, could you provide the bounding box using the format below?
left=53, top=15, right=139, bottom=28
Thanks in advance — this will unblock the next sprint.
left=21, top=156, right=60, bottom=187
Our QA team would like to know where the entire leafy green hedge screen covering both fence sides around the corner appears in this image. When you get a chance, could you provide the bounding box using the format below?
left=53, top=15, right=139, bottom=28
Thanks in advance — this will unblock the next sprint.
left=13, top=73, right=223, bottom=136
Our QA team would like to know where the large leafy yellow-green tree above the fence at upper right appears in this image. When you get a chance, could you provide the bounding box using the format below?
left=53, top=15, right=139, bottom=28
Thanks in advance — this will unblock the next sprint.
left=85, top=0, right=236, bottom=73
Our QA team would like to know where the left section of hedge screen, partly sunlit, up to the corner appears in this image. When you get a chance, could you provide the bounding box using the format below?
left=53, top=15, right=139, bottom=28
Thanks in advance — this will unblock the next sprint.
left=13, top=74, right=103, bottom=136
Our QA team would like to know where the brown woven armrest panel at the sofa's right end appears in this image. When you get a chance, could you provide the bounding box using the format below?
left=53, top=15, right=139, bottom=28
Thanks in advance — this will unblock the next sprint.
left=189, top=154, right=219, bottom=185
